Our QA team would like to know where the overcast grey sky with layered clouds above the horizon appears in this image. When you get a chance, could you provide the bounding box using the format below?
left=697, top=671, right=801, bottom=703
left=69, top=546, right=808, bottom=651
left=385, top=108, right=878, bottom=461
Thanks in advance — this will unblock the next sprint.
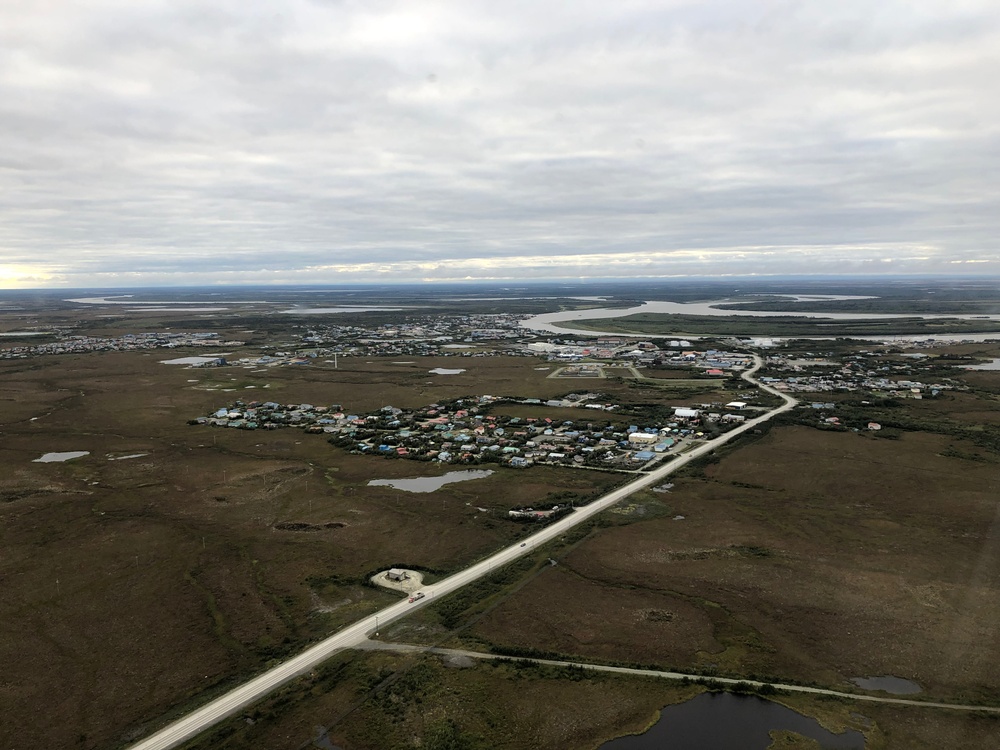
left=0, top=0, right=1000, bottom=287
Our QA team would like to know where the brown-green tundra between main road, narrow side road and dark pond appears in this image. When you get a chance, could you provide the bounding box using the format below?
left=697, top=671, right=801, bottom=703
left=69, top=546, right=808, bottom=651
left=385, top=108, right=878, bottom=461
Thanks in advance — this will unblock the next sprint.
left=178, top=651, right=712, bottom=750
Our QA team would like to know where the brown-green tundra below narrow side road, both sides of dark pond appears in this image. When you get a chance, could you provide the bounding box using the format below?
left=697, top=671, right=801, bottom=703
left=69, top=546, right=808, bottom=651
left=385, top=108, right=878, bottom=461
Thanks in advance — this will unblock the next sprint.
left=176, top=651, right=1000, bottom=750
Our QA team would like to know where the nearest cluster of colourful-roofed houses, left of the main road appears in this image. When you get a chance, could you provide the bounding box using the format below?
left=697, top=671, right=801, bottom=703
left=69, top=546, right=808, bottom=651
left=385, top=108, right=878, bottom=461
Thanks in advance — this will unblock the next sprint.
left=191, top=394, right=746, bottom=469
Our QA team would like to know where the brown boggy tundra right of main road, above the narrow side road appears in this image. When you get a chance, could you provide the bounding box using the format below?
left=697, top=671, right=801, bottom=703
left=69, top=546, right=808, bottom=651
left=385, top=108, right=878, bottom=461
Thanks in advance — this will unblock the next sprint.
left=462, top=414, right=1000, bottom=704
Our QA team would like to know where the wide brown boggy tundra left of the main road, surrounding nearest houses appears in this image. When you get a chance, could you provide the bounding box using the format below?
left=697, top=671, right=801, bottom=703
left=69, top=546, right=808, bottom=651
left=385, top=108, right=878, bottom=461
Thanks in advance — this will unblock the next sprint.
left=0, top=350, right=620, bottom=748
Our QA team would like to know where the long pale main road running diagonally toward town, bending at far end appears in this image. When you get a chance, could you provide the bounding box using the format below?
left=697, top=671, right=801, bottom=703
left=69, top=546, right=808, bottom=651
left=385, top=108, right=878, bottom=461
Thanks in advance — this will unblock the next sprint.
left=131, top=356, right=797, bottom=750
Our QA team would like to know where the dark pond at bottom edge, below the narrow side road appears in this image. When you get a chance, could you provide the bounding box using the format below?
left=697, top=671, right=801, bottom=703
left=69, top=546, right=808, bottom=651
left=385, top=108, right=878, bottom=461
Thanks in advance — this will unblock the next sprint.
left=601, top=693, right=865, bottom=750
